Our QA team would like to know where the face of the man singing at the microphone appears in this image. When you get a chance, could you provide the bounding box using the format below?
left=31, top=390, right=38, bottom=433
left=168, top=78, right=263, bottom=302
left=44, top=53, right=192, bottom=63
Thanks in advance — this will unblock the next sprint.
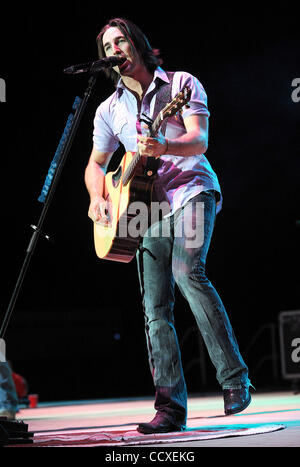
left=102, top=27, right=141, bottom=76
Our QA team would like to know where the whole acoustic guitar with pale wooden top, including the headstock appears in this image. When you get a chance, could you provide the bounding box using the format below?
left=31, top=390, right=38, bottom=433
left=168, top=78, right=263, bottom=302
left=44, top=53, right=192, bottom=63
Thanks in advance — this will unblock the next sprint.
left=94, top=86, right=191, bottom=263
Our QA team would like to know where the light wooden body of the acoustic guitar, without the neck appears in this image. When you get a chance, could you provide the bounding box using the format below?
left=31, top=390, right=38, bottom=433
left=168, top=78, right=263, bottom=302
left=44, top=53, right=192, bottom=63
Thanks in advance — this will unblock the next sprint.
left=94, top=152, right=154, bottom=263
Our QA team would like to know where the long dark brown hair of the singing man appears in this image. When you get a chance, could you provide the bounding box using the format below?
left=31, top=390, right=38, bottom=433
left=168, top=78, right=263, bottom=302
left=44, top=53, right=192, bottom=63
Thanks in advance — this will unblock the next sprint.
left=96, top=18, right=162, bottom=83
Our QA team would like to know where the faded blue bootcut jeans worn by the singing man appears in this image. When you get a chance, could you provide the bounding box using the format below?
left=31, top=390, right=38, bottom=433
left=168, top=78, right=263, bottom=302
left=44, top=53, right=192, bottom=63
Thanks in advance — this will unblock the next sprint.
left=137, top=190, right=250, bottom=425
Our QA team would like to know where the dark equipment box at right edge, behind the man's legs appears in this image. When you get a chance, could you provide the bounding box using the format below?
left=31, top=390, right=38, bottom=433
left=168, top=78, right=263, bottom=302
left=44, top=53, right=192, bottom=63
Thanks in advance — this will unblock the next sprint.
left=279, top=310, right=300, bottom=380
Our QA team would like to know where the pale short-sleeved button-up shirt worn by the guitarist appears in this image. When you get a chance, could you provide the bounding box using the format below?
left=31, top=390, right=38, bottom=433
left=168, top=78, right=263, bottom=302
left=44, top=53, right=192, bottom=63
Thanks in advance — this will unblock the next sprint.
left=93, top=67, right=222, bottom=214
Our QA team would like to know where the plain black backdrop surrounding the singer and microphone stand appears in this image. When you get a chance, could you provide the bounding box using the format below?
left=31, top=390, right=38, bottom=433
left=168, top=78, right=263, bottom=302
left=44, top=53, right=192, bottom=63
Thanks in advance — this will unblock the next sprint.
left=0, top=1, right=300, bottom=400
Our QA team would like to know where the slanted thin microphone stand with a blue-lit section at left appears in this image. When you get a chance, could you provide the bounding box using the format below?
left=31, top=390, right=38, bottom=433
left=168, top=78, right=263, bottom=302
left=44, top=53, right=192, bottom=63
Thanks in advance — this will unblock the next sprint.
left=0, top=73, right=98, bottom=339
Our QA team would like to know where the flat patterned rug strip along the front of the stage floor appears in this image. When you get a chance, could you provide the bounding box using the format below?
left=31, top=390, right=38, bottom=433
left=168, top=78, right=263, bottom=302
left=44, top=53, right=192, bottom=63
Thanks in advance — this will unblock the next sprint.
left=11, top=424, right=285, bottom=447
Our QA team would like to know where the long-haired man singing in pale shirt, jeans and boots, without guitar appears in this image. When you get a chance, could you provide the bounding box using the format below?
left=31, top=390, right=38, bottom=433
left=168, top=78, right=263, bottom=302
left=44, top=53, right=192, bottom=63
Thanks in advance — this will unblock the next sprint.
left=85, top=18, right=251, bottom=434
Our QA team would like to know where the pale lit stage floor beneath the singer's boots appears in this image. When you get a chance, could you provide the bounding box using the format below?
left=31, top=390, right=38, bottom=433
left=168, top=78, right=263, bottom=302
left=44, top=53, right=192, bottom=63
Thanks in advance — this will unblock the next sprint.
left=13, top=391, right=300, bottom=448
